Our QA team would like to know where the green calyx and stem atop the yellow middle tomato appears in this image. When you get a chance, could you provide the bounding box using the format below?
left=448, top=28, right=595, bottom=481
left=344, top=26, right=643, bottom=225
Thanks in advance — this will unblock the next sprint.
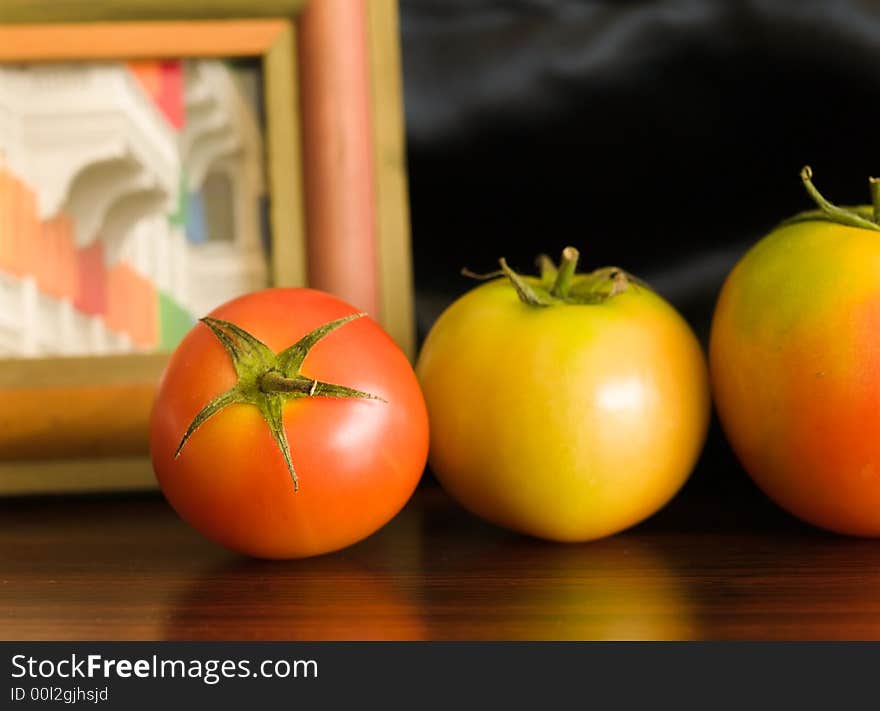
left=462, top=247, right=646, bottom=306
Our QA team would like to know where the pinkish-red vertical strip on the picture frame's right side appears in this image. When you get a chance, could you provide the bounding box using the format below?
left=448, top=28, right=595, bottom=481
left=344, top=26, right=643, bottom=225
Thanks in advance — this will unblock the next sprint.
left=298, top=0, right=379, bottom=316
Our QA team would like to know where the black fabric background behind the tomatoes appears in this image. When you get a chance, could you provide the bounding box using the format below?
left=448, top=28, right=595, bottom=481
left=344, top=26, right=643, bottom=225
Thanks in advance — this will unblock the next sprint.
left=401, top=0, right=880, bottom=519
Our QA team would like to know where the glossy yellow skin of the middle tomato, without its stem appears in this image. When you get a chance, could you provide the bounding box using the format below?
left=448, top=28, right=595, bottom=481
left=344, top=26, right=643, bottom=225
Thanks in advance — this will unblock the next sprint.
left=416, top=280, right=709, bottom=541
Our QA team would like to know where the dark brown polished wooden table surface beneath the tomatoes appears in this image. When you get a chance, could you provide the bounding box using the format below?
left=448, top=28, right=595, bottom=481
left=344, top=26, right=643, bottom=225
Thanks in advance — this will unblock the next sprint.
left=0, top=483, right=880, bottom=640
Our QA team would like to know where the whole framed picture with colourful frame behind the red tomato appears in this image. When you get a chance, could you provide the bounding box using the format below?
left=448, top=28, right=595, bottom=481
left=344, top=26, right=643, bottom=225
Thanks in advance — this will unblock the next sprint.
left=0, top=0, right=413, bottom=494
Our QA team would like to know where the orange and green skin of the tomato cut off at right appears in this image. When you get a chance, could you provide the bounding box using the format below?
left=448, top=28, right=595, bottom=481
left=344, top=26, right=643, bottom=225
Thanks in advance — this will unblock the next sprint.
left=710, top=220, right=880, bottom=536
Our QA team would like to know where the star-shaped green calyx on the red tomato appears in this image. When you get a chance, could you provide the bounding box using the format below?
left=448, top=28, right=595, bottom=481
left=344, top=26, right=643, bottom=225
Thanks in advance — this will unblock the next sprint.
left=174, top=314, right=385, bottom=491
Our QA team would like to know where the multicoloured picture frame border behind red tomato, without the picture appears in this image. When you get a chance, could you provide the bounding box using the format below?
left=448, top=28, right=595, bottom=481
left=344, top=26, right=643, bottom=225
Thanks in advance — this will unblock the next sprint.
left=0, top=0, right=414, bottom=495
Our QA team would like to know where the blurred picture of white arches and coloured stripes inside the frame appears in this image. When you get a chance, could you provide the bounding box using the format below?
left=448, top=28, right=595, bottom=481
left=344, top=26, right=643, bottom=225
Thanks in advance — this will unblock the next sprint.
left=0, top=59, right=280, bottom=358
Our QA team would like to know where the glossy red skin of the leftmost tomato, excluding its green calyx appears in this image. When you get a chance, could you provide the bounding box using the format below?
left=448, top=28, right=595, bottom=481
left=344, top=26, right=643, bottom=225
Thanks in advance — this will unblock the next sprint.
left=150, top=289, right=428, bottom=558
